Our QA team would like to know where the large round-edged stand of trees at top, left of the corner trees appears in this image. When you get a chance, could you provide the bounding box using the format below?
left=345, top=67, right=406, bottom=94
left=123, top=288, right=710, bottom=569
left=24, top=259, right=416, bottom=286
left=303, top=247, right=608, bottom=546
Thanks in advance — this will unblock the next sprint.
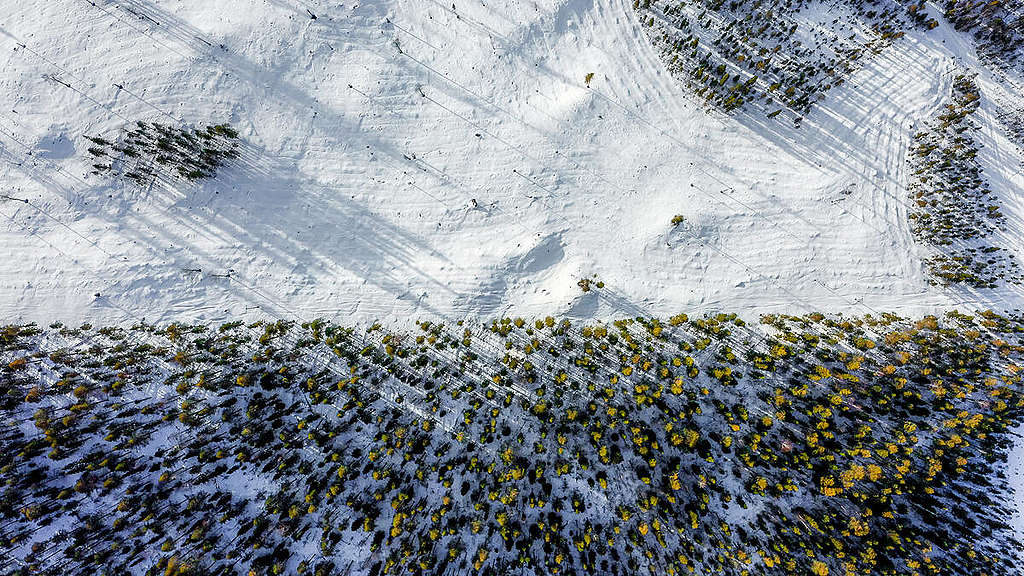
left=634, top=0, right=937, bottom=118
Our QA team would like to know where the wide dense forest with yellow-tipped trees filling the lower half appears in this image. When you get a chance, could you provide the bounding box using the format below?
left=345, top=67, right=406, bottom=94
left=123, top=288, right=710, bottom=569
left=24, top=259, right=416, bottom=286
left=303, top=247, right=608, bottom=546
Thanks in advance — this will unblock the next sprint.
left=0, top=313, right=1024, bottom=576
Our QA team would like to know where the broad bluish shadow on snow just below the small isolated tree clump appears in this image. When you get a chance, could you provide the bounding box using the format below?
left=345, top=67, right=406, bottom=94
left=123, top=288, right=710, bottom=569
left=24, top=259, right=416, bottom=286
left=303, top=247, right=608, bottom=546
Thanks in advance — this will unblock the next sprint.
left=103, top=134, right=453, bottom=314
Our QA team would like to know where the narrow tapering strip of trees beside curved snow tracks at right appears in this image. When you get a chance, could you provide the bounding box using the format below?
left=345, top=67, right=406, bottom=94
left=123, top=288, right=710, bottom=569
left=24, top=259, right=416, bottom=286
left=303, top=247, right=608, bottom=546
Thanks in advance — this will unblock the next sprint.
left=908, top=75, right=1020, bottom=288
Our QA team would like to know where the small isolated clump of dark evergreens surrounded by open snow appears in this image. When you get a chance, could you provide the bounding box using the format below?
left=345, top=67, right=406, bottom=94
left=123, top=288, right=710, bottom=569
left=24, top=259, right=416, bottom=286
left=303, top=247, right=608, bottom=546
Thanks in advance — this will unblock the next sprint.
left=86, top=121, right=239, bottom=183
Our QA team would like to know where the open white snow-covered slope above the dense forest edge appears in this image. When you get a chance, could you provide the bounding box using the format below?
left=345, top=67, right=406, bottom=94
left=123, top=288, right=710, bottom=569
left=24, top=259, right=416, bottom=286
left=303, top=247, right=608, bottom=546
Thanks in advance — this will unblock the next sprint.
left=0, top=0, right=1022, bottom=327
